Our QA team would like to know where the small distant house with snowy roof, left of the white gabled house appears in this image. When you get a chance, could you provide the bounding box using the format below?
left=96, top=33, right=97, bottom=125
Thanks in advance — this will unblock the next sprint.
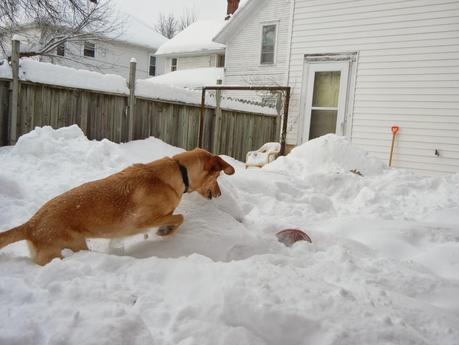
left=155, top=18, right=227, bottom=72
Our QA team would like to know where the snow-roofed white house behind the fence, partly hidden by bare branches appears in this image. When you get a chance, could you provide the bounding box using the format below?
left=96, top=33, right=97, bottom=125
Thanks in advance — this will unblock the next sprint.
left=4, top=20, right=167, bottom=79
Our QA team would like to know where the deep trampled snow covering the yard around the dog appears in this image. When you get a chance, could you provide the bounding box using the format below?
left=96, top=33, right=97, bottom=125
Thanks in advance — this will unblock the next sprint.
left=0, top=126, right=459, bottom=345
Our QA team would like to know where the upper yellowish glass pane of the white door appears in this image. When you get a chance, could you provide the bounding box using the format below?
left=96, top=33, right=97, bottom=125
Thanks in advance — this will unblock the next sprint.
left=312, top=71, right=341, bottom=108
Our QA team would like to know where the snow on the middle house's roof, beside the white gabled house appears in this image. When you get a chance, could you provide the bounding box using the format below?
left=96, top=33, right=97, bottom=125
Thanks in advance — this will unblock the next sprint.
left=156, top=20, right=227, bottom=55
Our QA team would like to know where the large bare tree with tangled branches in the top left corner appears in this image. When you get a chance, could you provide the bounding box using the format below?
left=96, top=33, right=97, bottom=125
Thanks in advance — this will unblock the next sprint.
left=0, top=0, right=120, bottom=56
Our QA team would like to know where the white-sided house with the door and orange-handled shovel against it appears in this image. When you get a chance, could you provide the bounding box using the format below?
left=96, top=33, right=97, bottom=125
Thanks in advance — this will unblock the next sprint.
left=214, top=0, right=459, bottom=173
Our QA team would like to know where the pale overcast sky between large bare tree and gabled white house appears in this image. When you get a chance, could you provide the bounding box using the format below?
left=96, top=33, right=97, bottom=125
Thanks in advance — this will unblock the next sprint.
left=113, top=0, right=234, bottom=25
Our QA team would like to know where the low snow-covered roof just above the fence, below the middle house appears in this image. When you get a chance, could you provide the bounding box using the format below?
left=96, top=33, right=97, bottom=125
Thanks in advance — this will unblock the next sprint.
left=145, top=67, right=225, bottom=88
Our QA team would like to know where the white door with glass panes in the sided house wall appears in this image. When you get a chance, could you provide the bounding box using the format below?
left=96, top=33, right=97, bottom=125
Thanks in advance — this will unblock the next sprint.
left=303, top=61, right=349, bottom=141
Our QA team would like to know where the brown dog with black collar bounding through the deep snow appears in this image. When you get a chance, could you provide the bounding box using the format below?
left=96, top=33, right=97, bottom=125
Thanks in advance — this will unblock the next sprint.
left=0, top=149, right=234, bottom=265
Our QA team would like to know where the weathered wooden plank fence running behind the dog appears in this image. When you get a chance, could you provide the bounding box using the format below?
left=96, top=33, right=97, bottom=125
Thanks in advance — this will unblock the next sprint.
left=0, top=79, right=280, bottom=160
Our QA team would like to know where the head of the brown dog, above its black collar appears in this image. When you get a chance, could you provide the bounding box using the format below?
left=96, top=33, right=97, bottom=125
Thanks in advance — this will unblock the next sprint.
left=174, top=149, right=234, bottom=199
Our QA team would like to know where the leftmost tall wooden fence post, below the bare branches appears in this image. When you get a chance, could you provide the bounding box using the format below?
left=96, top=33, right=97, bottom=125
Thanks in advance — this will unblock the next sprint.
left=8, top=37, right=21, bottom=145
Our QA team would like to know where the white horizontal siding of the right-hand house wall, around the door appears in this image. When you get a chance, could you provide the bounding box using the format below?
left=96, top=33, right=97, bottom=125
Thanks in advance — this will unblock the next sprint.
left=290, top=0, right=459, bottom=173
